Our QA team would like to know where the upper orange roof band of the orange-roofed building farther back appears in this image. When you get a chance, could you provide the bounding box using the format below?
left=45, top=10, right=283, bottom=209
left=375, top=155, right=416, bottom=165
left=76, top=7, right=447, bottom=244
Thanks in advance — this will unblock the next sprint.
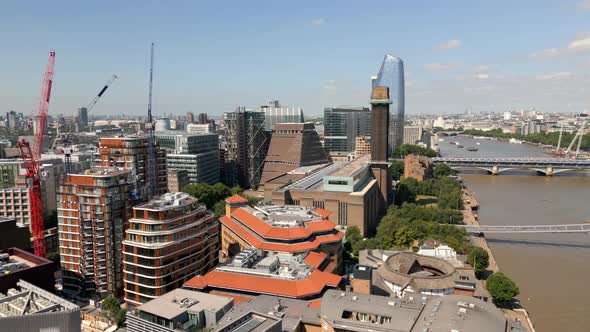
left=231, top=209, right=336, bottom=240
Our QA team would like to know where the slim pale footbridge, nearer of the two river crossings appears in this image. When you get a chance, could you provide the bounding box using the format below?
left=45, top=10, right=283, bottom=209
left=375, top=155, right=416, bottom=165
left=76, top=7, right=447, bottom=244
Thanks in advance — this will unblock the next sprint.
left=457, top=224, right=590, bottom=236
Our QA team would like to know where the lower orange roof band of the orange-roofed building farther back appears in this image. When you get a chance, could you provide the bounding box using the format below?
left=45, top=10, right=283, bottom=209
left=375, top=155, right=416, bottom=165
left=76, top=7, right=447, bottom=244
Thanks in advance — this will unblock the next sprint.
left=219, top=215, right=344, bottom=252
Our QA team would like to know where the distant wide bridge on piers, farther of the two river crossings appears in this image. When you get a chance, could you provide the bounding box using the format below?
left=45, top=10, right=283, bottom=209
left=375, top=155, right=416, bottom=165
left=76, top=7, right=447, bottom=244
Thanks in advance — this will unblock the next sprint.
left=432, top=157, right=590, bottom=176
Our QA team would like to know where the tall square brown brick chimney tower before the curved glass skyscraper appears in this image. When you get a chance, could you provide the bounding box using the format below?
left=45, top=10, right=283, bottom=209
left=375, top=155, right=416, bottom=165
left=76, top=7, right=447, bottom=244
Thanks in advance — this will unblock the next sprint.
left=371, top=86, right=392, bottom=214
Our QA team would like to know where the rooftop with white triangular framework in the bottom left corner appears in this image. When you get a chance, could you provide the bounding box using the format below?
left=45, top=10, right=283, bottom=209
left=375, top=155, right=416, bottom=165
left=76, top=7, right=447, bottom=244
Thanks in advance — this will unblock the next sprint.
left=0, top=280, right=80, bottom=318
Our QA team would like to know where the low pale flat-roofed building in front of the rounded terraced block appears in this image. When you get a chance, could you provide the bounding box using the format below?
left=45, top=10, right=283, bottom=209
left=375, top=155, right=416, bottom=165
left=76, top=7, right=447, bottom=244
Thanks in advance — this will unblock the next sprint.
left=127, top=289, right=233, bottom=332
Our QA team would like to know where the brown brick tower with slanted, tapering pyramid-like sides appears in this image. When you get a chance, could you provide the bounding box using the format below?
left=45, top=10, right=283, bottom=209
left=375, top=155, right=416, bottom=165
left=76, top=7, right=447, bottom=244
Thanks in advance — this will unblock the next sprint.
left=260, top=122, right=328, bottom=185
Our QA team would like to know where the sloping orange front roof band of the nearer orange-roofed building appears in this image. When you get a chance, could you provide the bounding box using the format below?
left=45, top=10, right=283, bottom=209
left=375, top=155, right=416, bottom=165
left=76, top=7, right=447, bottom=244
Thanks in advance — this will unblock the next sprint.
left=183, top=270, right=342, bottom=298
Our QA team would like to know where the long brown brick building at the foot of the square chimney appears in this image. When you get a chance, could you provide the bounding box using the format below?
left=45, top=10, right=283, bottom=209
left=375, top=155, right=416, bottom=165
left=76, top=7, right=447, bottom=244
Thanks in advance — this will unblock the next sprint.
left=264, top=155, right=381, bottom=236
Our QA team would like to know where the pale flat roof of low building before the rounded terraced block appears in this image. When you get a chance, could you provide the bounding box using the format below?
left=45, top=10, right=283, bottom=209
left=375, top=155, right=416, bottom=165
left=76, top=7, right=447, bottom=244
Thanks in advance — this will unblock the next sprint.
left=137, top=288, right=233, bottom=320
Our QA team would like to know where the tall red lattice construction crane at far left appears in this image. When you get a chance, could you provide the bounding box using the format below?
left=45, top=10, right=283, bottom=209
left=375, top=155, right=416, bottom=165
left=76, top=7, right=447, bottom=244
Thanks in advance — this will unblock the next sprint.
left=18, top=51, right=55, bottom=257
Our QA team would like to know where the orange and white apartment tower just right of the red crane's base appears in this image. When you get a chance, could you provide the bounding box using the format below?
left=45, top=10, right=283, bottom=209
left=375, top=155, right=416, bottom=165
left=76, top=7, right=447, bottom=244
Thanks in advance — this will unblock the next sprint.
left=57, top=168, right=132, bottom=299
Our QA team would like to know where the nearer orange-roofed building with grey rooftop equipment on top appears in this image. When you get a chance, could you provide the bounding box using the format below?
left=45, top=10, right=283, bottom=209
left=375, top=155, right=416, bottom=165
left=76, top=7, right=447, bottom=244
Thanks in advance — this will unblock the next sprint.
left=184, top=248, right=342, bottom=301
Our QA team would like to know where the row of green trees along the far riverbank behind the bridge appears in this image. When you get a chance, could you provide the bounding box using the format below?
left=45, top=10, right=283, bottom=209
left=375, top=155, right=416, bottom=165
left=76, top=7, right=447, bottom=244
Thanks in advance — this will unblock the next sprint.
left=464, top=129, right=590, bottom=150
